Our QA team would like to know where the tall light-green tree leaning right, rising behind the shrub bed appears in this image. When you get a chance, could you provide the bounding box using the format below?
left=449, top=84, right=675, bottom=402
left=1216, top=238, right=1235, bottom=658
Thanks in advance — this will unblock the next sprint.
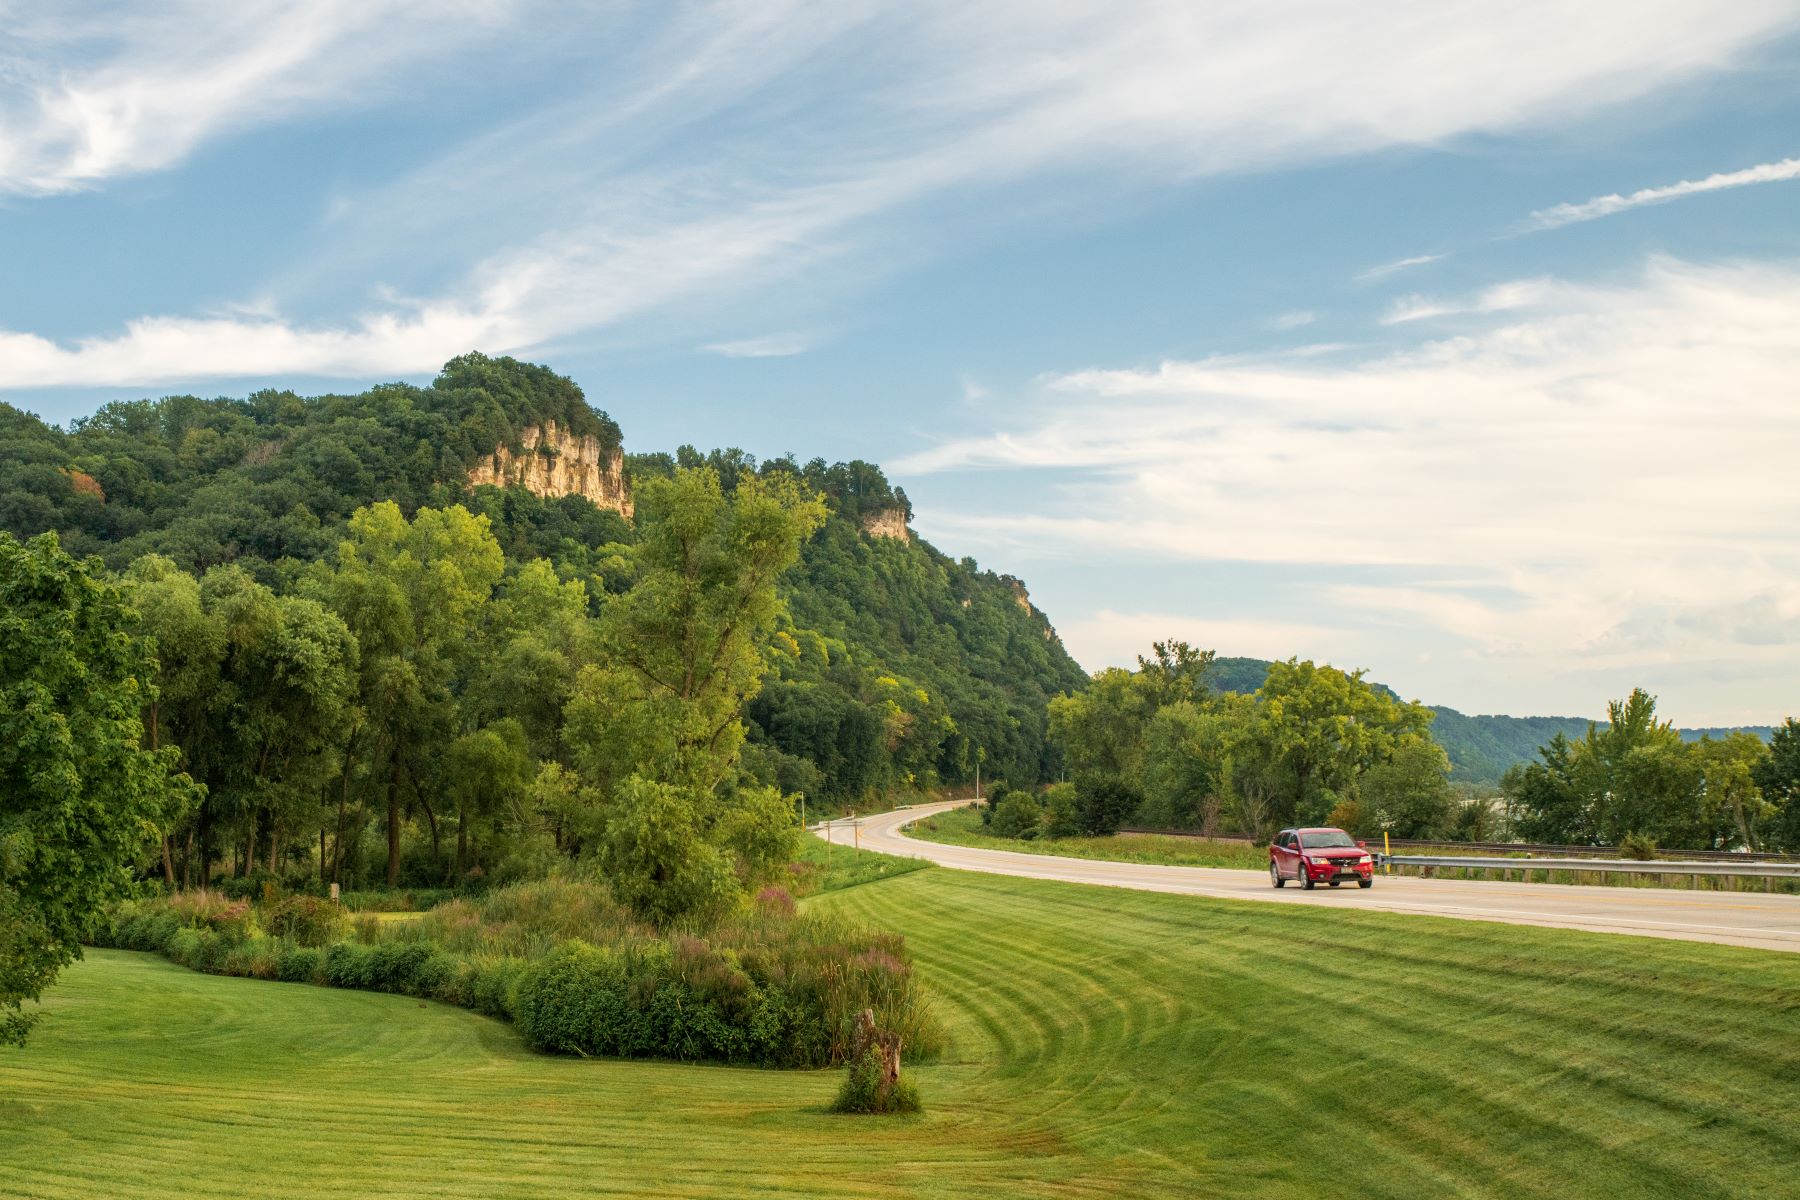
left=567, top=466, right=824, bottom=921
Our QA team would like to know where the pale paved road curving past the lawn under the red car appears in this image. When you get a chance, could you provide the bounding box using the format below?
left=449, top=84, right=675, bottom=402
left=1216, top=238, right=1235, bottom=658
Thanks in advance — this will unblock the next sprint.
left=819, top=801, right=1800, bottom=952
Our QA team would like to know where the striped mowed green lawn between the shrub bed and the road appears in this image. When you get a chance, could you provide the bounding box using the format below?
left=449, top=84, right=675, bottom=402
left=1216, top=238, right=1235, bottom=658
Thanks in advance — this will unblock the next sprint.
left=0, top=869, right=1800, bottom=1200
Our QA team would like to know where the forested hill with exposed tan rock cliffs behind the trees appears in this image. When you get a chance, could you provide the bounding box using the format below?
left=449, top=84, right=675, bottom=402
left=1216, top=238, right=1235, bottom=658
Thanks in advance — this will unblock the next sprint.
left=0, top=354, right=1084, bottom=802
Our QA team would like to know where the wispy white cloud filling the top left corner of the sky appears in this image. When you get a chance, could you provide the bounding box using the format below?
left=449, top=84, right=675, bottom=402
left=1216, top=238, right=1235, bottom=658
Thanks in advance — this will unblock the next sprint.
left=0, top=0, right=508, bottom=194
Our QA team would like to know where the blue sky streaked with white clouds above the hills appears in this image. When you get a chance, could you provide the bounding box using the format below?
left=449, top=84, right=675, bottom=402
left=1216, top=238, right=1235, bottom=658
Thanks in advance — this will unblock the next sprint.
left=0, top=0, right=1800, bottom=725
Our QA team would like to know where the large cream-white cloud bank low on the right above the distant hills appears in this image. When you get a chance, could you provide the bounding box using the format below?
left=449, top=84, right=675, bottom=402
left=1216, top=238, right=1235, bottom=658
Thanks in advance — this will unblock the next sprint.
left=895, top=259, right=1800, bottom=694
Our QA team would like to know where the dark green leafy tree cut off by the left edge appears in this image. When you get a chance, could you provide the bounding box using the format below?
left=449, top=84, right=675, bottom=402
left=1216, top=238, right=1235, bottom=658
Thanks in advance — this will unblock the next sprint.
left=0, top=533, right=196, bottom=1043
